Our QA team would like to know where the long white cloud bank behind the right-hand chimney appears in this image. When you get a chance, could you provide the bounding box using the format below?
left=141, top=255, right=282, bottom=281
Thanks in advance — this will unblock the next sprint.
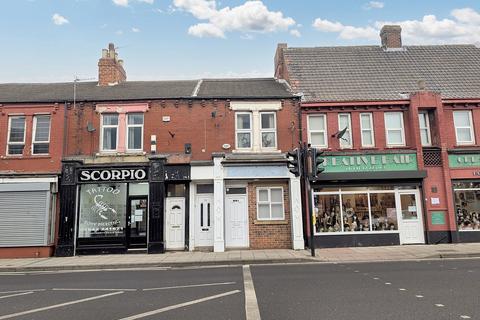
left=313, top=8, right=480, bottom=44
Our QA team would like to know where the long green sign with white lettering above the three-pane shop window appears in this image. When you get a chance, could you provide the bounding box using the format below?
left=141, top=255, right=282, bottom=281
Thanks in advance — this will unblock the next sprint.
left=323, top=153, right=418, bottom=173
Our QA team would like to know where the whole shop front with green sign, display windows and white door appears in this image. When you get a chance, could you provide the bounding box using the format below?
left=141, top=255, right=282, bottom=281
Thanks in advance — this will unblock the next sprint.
left=312, top=153, right=426, bottom=248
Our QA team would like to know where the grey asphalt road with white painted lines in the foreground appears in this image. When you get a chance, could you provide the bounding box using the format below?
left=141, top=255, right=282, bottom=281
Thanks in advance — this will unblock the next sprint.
left=0, top=259, right=480, bottom=320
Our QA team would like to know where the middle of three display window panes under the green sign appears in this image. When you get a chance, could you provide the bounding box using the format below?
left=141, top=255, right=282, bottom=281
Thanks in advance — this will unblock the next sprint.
left=342, top=193, right=370, bottom=232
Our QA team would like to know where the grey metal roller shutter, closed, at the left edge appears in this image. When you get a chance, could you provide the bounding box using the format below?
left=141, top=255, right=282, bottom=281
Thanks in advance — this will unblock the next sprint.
left=0, top=190, right=49, bottom=247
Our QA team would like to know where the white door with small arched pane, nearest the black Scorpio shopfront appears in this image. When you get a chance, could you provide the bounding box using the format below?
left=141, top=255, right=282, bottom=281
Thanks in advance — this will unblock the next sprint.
left=165, top=197, right=185, bottom=250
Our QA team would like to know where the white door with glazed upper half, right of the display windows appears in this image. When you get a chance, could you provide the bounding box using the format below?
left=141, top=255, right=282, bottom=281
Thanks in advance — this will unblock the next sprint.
left=397, top=190, right=425, bottom=244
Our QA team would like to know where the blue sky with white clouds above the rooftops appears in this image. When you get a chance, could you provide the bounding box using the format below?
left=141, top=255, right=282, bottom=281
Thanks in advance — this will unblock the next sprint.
left=0, top=0, right=480, bottom=83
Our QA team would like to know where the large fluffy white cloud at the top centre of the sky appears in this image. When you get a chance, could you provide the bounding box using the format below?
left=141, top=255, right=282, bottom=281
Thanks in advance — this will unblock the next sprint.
left=173, top=0, right=295, bottom=38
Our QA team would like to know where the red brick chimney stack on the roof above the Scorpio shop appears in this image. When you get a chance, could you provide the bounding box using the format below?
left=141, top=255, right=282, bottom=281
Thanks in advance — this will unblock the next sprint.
left=98, top=43, right=127, bottom=86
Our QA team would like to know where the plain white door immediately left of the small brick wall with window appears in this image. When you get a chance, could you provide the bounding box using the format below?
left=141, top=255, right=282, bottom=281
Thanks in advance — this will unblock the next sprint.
left=225, top=195, right=248, bottom=248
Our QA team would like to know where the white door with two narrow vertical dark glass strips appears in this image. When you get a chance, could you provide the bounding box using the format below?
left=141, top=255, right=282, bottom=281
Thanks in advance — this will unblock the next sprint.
left=195, top=195, right=213, bottom=247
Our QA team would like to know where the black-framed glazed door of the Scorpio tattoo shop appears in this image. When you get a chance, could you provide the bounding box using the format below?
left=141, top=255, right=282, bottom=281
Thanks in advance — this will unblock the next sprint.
left=127, top=197, right=148, bottom=248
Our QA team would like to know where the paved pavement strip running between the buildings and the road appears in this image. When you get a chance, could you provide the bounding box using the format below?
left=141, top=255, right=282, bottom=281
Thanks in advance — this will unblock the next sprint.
left=0, top=243, right=480, bottom=272
